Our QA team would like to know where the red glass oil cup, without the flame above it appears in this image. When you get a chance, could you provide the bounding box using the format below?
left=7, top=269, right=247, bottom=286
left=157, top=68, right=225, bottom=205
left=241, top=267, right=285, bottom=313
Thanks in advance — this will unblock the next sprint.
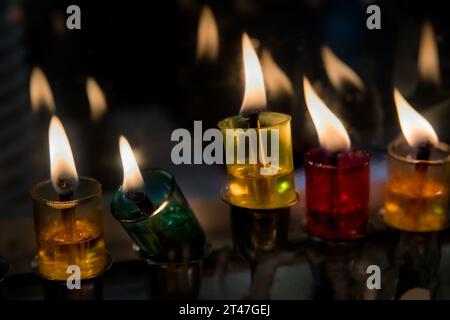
left=305, top=148, right=370, bottom=240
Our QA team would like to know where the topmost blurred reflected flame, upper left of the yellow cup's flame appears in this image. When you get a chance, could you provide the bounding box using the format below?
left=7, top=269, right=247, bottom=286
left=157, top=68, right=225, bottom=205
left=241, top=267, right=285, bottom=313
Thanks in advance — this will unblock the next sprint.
left=196, top=6, right=219, bottom=62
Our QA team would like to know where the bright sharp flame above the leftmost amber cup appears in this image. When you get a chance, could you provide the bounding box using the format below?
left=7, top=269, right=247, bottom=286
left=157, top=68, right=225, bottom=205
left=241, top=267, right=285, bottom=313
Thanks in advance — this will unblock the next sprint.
left=48, top=116, right=78, bottom=195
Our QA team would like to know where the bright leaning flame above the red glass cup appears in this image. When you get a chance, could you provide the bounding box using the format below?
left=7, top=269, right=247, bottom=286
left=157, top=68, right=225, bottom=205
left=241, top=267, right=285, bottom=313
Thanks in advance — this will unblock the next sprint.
left=303, top=77, right=350, bottom=153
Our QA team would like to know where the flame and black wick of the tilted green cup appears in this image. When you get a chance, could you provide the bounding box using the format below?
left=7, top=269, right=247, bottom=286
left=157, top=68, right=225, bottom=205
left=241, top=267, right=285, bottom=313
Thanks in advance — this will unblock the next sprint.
left=119, top=135, right=157, bottom=216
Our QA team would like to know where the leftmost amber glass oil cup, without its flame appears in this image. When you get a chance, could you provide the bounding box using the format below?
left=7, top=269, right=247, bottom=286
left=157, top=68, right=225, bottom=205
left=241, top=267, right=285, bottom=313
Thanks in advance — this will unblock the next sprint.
left=31, top=177, right=108, bottom=280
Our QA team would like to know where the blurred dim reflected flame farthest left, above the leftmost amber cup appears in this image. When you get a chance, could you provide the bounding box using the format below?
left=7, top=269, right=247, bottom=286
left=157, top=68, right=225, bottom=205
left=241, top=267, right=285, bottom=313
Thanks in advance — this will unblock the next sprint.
left=30, top=67, right=55, bottom=113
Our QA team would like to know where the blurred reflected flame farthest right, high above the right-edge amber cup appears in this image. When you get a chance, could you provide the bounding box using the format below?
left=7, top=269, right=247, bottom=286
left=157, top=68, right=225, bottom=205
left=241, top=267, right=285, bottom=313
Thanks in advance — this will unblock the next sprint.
left=418, top=22, right=441, bottom=86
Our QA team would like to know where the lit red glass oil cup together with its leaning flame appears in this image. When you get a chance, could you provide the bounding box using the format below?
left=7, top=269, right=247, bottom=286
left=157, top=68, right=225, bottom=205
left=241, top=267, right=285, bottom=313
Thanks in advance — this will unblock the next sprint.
left=303, top=77, right=369, bottom=240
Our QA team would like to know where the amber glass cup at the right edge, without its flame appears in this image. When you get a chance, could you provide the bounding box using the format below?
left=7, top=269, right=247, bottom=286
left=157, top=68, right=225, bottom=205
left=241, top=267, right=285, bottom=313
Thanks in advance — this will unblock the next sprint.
left=383, top=139, right=450, bottom=232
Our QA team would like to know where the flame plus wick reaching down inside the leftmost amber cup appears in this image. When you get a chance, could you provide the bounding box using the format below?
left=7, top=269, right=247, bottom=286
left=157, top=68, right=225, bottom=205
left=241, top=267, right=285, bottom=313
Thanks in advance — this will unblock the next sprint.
left=48, top=116, right=78, bottom=240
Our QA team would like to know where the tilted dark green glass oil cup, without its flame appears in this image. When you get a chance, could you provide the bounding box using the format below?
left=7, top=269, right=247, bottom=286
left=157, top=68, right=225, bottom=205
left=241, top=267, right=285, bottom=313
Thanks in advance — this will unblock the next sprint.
left=111, top=169, right=205, bottom=262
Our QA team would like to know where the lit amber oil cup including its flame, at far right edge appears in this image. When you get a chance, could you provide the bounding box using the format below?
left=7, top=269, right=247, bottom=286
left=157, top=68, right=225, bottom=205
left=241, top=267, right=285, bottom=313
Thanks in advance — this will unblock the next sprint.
left=384, top=88, right=448, bottom=232
